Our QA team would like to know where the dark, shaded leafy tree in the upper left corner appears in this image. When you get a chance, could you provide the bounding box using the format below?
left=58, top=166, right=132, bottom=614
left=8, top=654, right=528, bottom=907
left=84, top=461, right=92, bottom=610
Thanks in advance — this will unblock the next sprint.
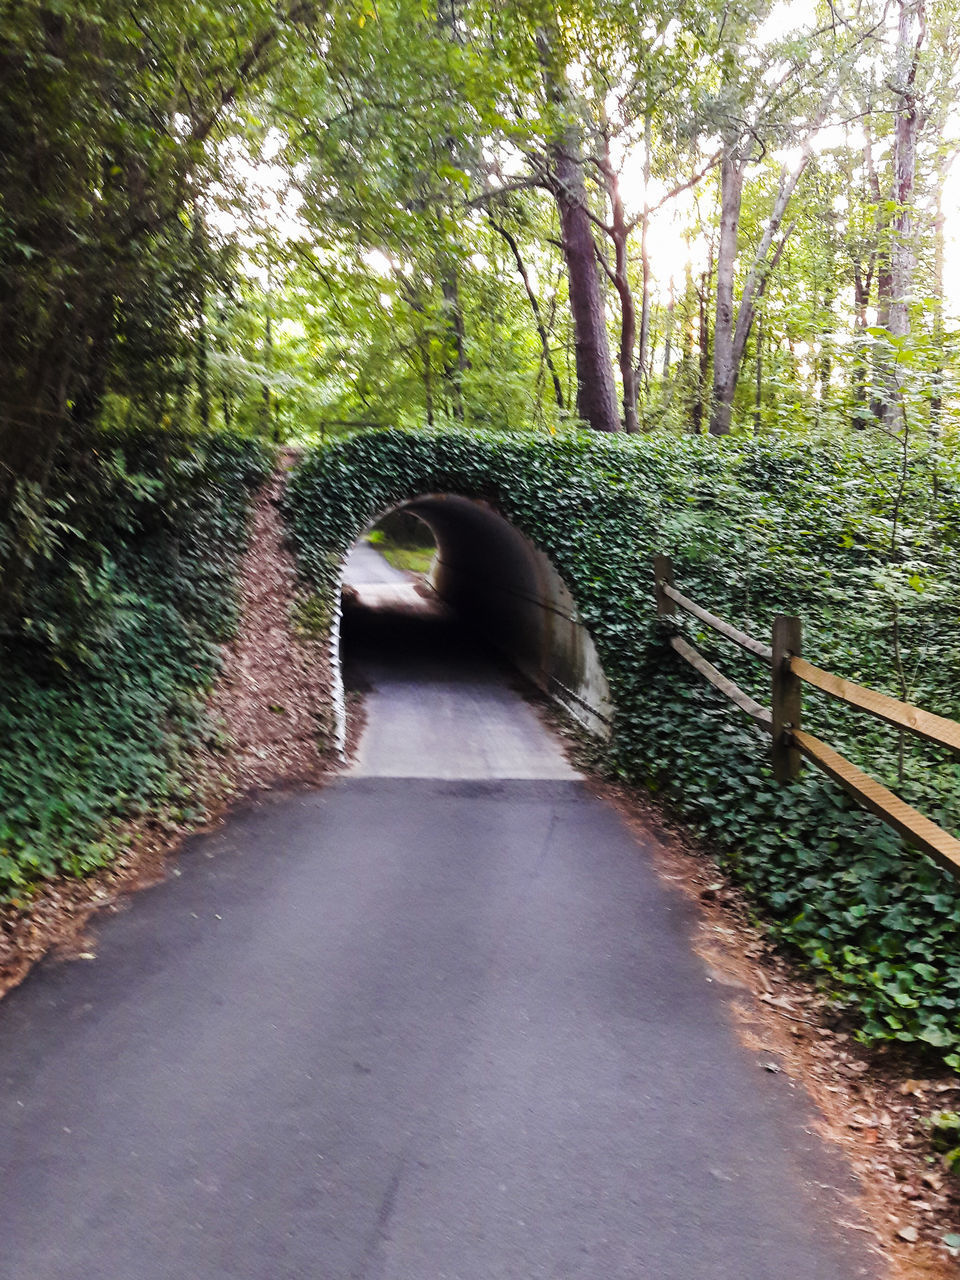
left=0, top=0, right=320, bottom=613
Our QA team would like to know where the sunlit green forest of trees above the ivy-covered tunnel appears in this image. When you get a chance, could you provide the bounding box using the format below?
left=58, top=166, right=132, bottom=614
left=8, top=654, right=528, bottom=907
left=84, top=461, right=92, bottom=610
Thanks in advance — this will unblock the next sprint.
left=0, top=0, right=960, bottom=486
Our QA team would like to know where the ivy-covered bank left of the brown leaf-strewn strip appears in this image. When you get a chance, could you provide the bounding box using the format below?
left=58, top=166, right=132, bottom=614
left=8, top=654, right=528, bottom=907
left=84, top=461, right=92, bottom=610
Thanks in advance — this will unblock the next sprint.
left=0, top=431, right=273, bottom=902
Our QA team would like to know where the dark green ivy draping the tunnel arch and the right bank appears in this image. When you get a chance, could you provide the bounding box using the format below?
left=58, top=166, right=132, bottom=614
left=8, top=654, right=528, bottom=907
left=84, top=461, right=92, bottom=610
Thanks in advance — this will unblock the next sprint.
left=287, top=431, right=960, bottom=1069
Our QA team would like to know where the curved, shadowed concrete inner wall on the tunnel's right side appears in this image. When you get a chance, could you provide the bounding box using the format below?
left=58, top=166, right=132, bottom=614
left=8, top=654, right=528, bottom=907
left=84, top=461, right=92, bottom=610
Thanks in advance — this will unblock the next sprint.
left=371, top=494, right=613, bottom=737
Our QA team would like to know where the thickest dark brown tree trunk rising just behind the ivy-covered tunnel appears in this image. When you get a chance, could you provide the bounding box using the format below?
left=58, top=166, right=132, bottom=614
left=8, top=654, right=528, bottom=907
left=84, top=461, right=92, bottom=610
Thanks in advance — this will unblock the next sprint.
left=536, top=28, right=621, bottom=431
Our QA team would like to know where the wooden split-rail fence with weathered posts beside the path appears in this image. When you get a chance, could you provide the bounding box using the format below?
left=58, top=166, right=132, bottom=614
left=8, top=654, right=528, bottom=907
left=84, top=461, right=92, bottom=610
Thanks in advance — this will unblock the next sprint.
left=654, top=556, right=960, bottom=879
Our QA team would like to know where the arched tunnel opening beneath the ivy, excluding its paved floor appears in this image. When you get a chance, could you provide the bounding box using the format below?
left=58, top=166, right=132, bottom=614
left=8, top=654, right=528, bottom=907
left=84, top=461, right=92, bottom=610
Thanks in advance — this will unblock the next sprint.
left=340, top=493, right=612, bottom=762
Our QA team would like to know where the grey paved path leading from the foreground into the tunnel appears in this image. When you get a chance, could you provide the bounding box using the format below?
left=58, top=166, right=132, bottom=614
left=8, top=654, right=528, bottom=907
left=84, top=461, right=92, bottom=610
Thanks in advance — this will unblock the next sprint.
left=0, top=547, right=879, bottom=1280
